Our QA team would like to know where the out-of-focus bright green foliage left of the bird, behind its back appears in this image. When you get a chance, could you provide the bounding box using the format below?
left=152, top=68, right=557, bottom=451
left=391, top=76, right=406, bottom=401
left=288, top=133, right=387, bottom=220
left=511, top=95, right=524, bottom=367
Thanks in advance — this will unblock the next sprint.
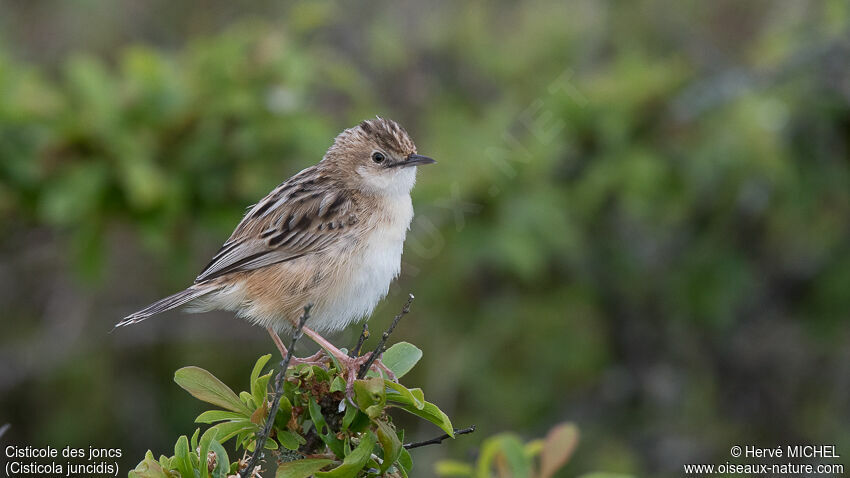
left=0, top=25, right=362, bottom=277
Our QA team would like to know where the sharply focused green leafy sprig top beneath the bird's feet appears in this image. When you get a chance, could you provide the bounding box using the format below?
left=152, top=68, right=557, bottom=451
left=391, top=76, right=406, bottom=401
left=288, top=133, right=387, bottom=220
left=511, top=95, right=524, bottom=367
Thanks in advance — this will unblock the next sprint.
left=130, top=342, right=453, bottom=478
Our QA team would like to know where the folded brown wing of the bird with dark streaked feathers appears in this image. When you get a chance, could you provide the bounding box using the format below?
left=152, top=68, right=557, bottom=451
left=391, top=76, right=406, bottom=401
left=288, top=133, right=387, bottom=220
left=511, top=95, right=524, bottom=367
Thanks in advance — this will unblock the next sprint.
left=195, top=168, right=358, bottom=283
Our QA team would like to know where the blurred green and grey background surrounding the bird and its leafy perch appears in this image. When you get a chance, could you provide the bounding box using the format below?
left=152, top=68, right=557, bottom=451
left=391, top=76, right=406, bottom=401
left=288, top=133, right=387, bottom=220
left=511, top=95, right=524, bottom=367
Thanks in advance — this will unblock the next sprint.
left=0, top=0, right=850, bottom=476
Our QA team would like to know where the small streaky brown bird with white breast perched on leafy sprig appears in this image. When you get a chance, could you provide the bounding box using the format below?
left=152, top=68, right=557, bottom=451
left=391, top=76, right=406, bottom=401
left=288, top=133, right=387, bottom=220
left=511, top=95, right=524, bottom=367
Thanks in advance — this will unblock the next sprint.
left=116, top=118, right=435, bottom=370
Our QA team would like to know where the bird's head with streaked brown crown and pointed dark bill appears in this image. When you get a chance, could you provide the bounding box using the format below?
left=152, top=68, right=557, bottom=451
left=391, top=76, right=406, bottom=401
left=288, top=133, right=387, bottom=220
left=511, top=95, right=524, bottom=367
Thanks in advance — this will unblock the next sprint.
left=322, top=118, right=435, bottom=195
